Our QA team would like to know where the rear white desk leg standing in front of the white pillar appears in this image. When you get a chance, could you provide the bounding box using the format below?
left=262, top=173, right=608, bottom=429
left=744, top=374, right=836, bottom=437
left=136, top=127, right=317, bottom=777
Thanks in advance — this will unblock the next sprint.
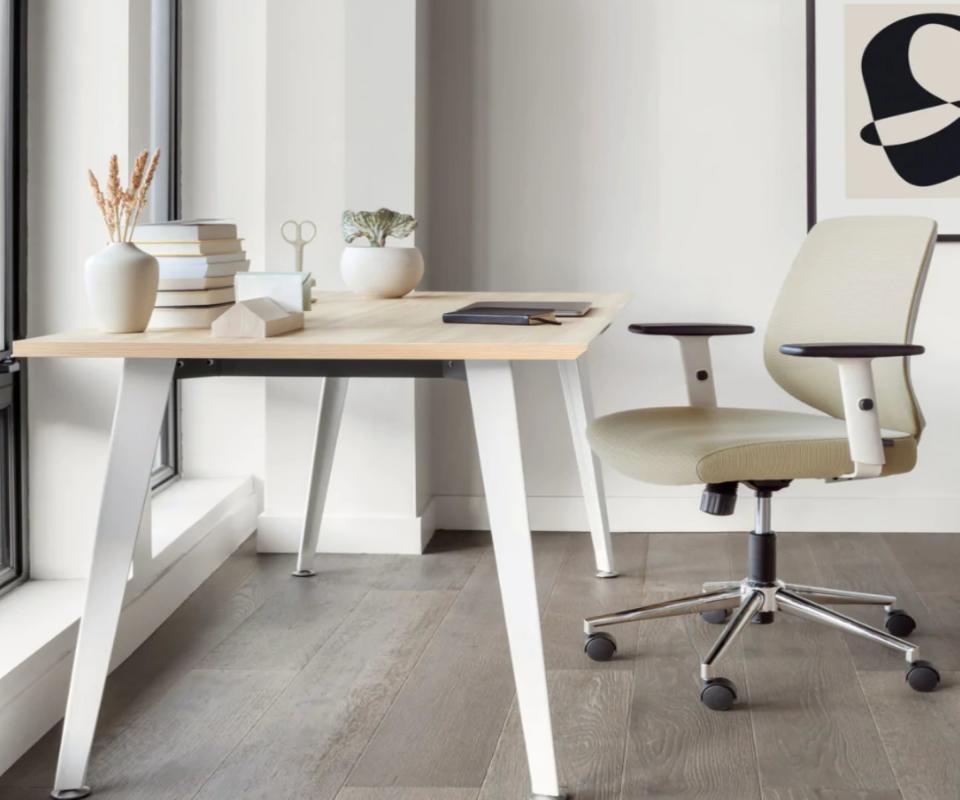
left=293, top=378, right=350, bottom=578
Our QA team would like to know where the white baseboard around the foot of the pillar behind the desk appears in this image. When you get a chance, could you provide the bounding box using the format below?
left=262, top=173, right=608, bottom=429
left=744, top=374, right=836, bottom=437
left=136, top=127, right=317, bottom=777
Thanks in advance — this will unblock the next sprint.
left=257, top=504, right=436, bottom=555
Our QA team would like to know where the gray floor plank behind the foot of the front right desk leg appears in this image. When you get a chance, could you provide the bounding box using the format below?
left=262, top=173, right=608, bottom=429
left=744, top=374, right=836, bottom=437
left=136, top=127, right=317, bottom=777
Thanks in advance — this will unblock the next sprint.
left=480, top=669, right=633, bottom=800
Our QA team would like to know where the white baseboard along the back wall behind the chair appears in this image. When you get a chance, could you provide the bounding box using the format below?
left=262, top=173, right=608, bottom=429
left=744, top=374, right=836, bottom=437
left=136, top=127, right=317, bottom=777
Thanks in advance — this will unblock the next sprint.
left=425, top=494, right=960, bottom=533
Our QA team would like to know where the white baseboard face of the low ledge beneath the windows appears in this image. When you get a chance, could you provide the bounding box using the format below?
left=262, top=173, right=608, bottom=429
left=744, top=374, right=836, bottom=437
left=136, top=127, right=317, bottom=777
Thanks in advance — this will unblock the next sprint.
left=0, top=480, right=260, bottom=783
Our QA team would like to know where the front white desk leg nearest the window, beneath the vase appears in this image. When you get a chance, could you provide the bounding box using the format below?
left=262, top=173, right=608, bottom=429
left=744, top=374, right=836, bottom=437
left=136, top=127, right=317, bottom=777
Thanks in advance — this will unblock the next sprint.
left=52, top=358, right=175, bottom=800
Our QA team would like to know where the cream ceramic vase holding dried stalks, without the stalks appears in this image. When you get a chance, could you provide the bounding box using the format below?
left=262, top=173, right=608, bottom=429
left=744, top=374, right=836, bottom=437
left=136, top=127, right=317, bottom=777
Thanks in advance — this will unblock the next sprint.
left=85, top=242, right=160, bottom=333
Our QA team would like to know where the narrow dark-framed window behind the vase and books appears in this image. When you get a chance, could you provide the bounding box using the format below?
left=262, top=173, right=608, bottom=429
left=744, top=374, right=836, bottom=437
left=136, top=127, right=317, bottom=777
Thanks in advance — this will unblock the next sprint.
left=147, top=0, right=180, bottom=490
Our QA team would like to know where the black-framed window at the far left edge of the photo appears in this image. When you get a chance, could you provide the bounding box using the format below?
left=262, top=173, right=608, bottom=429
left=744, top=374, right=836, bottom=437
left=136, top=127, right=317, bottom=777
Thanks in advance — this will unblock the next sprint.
left=0, top=0, right=27, bottom=592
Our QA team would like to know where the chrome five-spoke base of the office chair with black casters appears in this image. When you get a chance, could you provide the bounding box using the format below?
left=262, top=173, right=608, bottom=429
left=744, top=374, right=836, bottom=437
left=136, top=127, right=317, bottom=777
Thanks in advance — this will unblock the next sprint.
left=583, top=578, right=940, bottom=710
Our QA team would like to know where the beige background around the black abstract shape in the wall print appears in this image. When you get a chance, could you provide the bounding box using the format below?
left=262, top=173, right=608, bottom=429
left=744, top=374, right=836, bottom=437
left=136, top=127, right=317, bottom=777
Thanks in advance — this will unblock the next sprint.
left=838, top=3, right=960, bottom=199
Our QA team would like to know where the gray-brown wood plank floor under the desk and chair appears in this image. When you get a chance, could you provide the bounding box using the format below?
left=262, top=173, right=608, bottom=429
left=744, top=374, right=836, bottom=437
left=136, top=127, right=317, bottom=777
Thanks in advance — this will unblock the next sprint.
left=0, top=533, right=960, bottom=800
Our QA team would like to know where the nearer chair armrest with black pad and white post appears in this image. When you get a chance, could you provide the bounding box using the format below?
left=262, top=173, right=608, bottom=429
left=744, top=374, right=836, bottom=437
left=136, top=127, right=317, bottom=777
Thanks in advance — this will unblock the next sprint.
left=780, top=342, right=924, bottom=480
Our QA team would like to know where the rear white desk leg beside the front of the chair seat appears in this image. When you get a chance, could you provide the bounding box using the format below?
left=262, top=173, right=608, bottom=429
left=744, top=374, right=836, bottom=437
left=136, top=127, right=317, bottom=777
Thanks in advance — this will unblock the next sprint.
left=557, top=357, right=617, bottom=578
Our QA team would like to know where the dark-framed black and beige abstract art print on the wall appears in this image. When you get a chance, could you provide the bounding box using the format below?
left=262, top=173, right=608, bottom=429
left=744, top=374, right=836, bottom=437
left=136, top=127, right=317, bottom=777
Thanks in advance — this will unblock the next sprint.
left=807, top=0, right=960, bottom=241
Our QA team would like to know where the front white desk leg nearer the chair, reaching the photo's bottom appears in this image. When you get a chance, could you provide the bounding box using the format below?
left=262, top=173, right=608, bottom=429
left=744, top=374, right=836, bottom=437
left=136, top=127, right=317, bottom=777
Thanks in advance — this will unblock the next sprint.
left=466, top=361, right=564, bottom=800
